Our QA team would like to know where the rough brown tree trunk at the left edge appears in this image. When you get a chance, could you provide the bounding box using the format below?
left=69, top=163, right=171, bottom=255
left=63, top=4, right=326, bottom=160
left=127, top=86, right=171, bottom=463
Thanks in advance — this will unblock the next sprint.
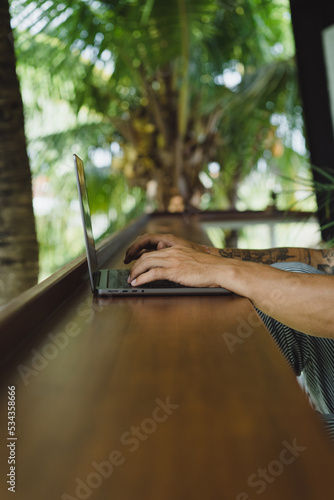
left=0, top=0, right=38, bottom=304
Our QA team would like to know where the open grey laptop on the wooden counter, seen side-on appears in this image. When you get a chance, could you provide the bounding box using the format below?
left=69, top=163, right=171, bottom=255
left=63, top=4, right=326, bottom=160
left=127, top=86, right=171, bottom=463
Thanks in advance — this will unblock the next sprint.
left=73, top=154, right=231, bottom=296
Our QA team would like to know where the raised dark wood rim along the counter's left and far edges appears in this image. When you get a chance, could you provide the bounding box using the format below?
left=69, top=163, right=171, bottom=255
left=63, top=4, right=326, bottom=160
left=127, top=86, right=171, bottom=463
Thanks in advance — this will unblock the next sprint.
left=0, top=209, right=314, bottom=360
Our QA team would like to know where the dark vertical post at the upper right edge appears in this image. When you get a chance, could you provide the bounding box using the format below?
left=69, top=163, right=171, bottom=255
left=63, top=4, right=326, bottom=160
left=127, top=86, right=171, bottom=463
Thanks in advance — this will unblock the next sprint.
left=290, top=0, right=334, bottom=240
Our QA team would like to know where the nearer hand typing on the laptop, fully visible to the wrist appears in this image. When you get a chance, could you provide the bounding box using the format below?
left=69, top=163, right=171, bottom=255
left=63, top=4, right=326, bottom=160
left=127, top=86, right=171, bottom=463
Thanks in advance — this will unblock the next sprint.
left=128, top=244, right=223, bottom=287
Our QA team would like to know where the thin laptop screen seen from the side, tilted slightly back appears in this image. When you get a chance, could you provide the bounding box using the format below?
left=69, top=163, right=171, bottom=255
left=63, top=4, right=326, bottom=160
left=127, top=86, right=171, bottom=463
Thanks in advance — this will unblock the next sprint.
left=73, top=154, right=98, bottom=291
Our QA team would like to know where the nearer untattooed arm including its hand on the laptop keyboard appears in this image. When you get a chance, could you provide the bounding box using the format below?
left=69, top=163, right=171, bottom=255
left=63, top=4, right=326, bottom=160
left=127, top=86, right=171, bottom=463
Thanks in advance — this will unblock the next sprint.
left=128, top=237, right=334, bottom=338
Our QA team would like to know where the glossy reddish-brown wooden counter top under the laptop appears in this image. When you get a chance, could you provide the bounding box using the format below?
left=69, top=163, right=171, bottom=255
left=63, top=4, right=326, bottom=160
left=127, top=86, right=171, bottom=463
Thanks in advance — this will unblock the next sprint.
left=0, top=213, right=334, bottom=500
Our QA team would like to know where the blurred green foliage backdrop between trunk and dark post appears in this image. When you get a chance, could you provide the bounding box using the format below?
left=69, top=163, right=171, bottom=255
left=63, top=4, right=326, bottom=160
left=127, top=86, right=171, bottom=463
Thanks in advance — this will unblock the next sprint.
left=7, top=0, right=315, bottom=274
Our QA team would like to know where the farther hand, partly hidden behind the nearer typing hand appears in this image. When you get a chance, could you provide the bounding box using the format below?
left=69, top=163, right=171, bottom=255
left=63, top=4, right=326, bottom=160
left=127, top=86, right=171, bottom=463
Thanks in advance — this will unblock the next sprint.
left=124, top=234, right=206, bottom=264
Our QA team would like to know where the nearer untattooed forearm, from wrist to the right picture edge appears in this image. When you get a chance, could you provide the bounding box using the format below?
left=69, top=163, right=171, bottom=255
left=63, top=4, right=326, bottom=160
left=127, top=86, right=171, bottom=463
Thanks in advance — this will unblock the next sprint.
left=217, top=260, right=334, bottom=338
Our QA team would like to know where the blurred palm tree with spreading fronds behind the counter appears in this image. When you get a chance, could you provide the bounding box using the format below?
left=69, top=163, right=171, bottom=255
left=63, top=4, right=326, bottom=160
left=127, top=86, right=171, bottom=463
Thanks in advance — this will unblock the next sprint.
left=11, top=0, right=296, bottom=209
